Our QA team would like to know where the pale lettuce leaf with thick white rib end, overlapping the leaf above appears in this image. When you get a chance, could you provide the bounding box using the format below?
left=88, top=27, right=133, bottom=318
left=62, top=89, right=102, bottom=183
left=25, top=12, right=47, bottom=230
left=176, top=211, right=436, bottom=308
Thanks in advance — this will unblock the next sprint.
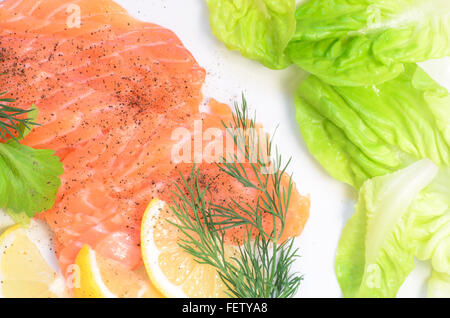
left=335, top=159, right=438, bottom=297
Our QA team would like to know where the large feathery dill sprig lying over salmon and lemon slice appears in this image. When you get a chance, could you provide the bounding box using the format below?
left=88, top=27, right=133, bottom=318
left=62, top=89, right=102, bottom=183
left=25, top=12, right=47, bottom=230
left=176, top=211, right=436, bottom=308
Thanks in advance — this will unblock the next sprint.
left=170, top=97, right=302, bottom=298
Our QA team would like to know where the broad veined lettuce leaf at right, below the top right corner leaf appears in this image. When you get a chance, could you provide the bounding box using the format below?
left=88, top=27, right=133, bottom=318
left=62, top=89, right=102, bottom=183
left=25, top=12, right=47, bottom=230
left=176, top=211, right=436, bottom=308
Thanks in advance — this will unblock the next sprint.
left=295, top=64, right=450, bottom=188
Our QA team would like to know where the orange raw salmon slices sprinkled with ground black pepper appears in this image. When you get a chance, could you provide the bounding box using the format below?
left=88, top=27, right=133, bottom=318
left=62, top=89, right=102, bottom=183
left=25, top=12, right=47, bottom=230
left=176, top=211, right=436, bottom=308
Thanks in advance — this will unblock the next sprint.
left=0, top=0, right=309, bottom=272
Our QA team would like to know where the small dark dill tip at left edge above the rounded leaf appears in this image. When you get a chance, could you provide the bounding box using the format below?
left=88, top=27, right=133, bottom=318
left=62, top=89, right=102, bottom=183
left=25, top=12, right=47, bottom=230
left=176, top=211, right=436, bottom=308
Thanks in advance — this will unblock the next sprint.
left=0, top=92, right=38, bottom=141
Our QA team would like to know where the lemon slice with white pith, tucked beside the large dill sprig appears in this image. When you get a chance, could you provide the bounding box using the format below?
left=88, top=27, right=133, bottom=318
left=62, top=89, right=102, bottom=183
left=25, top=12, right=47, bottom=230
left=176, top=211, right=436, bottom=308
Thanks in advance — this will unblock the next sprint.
left=141, top=199, right=230, bottom=298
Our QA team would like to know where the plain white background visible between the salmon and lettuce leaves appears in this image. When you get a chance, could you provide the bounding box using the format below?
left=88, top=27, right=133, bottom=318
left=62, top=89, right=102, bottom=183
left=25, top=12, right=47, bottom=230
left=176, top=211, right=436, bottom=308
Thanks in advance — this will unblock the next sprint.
left=110, top=0, right=450, bottom=297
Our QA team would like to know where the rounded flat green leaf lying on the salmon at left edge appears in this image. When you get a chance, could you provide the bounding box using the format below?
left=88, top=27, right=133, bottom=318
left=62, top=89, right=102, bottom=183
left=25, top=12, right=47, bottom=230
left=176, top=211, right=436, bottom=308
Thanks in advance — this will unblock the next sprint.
left=0, top=141, right=64, bottom=217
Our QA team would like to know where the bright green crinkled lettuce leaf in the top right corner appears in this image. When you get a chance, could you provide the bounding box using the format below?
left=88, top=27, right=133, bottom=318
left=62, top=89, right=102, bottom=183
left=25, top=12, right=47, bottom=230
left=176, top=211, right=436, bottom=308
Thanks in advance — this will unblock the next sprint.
left=286, top=0, right=450, bottom=86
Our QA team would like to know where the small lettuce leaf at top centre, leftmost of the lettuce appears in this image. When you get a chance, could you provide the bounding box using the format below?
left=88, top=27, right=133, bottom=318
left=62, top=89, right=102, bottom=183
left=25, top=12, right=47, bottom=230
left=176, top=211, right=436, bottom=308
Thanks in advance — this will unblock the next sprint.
left=206, top=0, right=295, bottom=69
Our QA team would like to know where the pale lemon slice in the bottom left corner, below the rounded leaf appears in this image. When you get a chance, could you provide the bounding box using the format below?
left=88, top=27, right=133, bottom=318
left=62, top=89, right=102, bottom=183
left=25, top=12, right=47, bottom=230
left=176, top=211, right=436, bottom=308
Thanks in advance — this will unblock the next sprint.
left=0, top=221, right=68, bottom=298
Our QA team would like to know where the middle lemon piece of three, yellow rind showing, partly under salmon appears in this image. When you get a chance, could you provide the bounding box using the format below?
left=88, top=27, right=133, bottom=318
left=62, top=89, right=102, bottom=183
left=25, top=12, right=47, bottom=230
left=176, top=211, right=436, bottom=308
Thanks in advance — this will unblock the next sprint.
left=74, top=245, right=162, bottom=298
